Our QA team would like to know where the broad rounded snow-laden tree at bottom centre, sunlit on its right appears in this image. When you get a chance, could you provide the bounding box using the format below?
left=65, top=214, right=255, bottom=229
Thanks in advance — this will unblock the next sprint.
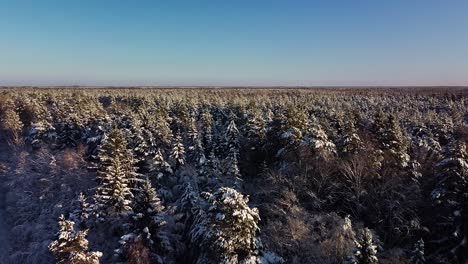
left=190, top=187, right=260, bottom=263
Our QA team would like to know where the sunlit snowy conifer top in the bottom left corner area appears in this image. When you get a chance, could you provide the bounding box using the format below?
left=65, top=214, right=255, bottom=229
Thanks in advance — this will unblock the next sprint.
left=49, top=215, right=102, bottom=264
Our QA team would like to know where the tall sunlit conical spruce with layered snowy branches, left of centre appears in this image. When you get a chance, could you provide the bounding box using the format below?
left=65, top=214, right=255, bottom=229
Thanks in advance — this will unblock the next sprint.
left=95, top=129, right=141, bottom=218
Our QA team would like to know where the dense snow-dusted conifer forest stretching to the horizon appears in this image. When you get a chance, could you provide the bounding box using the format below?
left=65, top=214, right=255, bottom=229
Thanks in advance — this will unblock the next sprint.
left=0, top=88, right=468, bottom=264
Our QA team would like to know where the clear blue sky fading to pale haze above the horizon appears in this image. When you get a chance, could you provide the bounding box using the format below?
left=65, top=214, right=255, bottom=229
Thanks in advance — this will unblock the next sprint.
left=0, top=0, right=468, bottom=85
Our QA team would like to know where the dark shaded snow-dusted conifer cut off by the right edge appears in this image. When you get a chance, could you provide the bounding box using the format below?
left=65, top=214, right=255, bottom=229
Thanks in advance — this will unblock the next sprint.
left=431, top=142, right=468, bottom=263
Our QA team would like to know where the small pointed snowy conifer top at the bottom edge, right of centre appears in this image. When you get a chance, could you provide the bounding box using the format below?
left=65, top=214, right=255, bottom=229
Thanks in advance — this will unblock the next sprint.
left=345, top=228, right=379, bottom=264
